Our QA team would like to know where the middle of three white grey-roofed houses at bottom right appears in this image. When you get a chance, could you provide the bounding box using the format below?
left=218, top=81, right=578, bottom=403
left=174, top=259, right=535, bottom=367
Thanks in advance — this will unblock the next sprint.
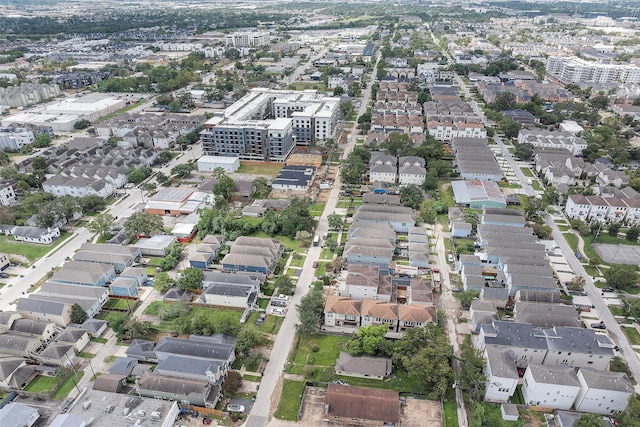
left=522, top=364, right=580, bottom=409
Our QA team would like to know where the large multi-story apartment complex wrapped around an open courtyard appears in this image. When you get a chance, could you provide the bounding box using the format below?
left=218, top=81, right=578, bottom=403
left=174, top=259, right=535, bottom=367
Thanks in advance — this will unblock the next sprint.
left=200, top=88, right=340, bottom=162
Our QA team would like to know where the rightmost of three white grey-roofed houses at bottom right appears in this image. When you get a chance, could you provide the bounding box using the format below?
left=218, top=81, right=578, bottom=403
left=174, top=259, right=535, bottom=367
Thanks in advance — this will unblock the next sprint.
left=575, top=368, right=634, bottom=415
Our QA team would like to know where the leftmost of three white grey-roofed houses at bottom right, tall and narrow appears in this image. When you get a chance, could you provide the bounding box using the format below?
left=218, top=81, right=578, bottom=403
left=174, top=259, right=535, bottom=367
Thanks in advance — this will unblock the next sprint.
left=484, top=347, right=519, bottom=402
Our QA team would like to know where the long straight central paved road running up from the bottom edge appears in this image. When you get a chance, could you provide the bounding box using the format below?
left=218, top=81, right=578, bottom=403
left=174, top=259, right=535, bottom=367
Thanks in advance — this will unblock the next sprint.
left=245, top=55, right=375, bottom=427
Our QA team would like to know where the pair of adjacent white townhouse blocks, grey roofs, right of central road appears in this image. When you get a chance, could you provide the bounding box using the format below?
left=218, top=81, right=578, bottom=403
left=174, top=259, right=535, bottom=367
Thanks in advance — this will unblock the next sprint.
left=369, top=151, right=427, bottom=185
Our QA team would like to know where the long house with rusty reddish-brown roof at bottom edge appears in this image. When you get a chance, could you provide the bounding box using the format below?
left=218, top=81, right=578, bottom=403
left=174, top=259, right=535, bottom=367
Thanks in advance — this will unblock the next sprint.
left=324, top=384, right=400, bottom=426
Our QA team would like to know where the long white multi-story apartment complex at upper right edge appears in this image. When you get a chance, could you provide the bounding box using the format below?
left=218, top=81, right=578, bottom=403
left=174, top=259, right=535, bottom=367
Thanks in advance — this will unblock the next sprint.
left=546, top=56, right=640, bottom=83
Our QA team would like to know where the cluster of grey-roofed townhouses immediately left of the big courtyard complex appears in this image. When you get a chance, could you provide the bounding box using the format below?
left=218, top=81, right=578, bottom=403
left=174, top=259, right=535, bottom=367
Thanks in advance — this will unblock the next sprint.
left=95, top=113, right=207, bottom=150
